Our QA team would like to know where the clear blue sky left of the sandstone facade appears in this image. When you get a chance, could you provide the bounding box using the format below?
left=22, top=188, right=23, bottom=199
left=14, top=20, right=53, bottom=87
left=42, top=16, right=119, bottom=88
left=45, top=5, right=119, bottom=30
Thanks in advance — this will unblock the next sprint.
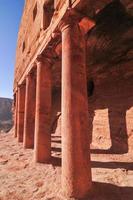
left=0, top=0, right=24, bottom=98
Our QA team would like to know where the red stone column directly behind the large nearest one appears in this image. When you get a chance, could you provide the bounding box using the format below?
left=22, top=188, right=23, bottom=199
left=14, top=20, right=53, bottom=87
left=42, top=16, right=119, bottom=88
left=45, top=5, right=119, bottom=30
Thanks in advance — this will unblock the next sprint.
left=35, top=56, right=52, bottom=163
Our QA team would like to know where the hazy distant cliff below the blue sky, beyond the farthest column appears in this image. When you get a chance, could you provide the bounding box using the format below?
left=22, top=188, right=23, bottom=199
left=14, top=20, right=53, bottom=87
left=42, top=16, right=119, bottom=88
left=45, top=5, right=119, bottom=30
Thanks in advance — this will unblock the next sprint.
left=0, top=98, right=13, bottom=131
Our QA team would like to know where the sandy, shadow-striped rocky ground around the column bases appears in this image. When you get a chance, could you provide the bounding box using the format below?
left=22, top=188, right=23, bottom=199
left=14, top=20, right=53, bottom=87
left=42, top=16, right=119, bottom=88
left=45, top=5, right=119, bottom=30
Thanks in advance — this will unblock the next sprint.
left=0, top=130, right=133, bottom=200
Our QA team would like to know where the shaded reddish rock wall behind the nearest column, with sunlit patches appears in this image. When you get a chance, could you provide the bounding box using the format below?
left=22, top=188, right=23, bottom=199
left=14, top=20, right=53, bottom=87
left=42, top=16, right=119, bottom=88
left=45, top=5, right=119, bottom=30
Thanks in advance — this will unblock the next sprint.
left=50, top=0, right=133, bottom=153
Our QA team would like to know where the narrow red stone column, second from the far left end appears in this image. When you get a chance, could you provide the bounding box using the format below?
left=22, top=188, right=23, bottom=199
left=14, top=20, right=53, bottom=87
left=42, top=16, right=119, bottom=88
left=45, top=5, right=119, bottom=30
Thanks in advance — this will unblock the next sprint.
left=17, top=84, right=25, bottom=142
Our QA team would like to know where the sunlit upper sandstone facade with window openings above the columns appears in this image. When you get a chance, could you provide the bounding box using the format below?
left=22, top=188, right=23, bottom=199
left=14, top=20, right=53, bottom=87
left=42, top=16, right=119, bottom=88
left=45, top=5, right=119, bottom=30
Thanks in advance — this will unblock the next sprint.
left=14, top=0, right=131, bottom=90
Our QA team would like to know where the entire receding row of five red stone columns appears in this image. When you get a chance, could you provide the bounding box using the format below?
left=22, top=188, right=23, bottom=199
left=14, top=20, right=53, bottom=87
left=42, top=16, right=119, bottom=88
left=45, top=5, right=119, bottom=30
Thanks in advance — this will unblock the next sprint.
left=15, top=14, right=92, bottom=198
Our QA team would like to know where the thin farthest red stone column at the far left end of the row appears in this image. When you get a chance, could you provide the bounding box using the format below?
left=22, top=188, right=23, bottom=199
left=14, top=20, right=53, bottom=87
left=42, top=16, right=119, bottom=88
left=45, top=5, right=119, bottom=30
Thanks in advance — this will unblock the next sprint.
left=14, top=91, right=18, bottom=137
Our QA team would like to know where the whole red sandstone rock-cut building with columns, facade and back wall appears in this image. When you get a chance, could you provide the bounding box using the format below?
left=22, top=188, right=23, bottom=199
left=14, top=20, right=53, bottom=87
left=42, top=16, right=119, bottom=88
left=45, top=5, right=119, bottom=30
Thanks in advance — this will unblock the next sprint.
left=14, top=0, right=133, bottom=199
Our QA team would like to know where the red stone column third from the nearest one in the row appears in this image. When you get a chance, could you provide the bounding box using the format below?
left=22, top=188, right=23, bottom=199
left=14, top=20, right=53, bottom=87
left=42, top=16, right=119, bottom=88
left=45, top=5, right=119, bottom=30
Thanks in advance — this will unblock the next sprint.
left=23, top=73, right=36, bottom=148
